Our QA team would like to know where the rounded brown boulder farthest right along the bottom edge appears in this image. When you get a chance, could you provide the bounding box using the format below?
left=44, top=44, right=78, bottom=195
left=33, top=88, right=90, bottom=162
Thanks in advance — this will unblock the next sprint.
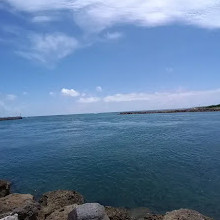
left=163, top=209, right=212, bottom=220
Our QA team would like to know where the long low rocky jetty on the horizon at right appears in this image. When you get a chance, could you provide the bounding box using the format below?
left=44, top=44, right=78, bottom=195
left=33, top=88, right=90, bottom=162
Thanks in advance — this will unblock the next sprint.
left=119, top=104, right=220, bottom=115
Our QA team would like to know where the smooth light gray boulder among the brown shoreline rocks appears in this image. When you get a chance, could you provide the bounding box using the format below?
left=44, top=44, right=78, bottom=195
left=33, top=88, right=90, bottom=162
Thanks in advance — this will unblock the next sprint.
left=68, top=203, right=109, bottom=220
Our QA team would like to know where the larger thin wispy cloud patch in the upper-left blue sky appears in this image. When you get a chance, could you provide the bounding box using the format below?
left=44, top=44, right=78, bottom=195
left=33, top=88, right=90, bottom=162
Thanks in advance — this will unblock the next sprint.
left=17, top=33, right=79, bottom=63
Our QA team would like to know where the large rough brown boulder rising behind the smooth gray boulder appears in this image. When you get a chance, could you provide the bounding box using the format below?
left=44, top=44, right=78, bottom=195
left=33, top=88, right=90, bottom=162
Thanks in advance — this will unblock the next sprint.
left=39, top=190, right=84, bottom=219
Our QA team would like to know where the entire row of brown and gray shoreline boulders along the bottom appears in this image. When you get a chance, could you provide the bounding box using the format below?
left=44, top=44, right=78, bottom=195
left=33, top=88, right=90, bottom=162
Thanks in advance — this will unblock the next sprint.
left=0, top=180, right=213, bottom=220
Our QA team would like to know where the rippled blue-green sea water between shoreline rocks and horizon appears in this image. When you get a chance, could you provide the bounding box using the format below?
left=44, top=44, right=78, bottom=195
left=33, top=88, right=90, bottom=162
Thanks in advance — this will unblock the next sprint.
left=0, top=112, right=220, bottom=219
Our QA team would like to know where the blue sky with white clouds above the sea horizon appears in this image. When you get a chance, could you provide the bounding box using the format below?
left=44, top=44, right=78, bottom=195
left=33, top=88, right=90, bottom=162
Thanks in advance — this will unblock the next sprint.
left=0, top=0, right=220, bottom=117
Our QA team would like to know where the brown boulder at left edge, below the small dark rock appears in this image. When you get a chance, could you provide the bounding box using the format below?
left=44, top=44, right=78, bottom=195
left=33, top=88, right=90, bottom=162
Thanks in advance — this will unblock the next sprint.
left=0, top=193, right=40, bottom=220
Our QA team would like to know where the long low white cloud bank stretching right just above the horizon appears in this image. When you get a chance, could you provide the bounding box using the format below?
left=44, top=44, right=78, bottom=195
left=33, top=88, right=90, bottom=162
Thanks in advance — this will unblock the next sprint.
left=58, top=89, right=220, bottom=108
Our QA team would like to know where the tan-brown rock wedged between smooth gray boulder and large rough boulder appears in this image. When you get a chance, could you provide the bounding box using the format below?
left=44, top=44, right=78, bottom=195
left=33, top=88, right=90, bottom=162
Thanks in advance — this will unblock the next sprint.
left=46, top=204, right=77, bottom=220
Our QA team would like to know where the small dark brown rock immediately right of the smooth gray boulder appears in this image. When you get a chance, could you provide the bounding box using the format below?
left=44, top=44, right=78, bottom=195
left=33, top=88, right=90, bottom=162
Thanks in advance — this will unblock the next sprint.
left=105, top=206, right=131, bottom=220
